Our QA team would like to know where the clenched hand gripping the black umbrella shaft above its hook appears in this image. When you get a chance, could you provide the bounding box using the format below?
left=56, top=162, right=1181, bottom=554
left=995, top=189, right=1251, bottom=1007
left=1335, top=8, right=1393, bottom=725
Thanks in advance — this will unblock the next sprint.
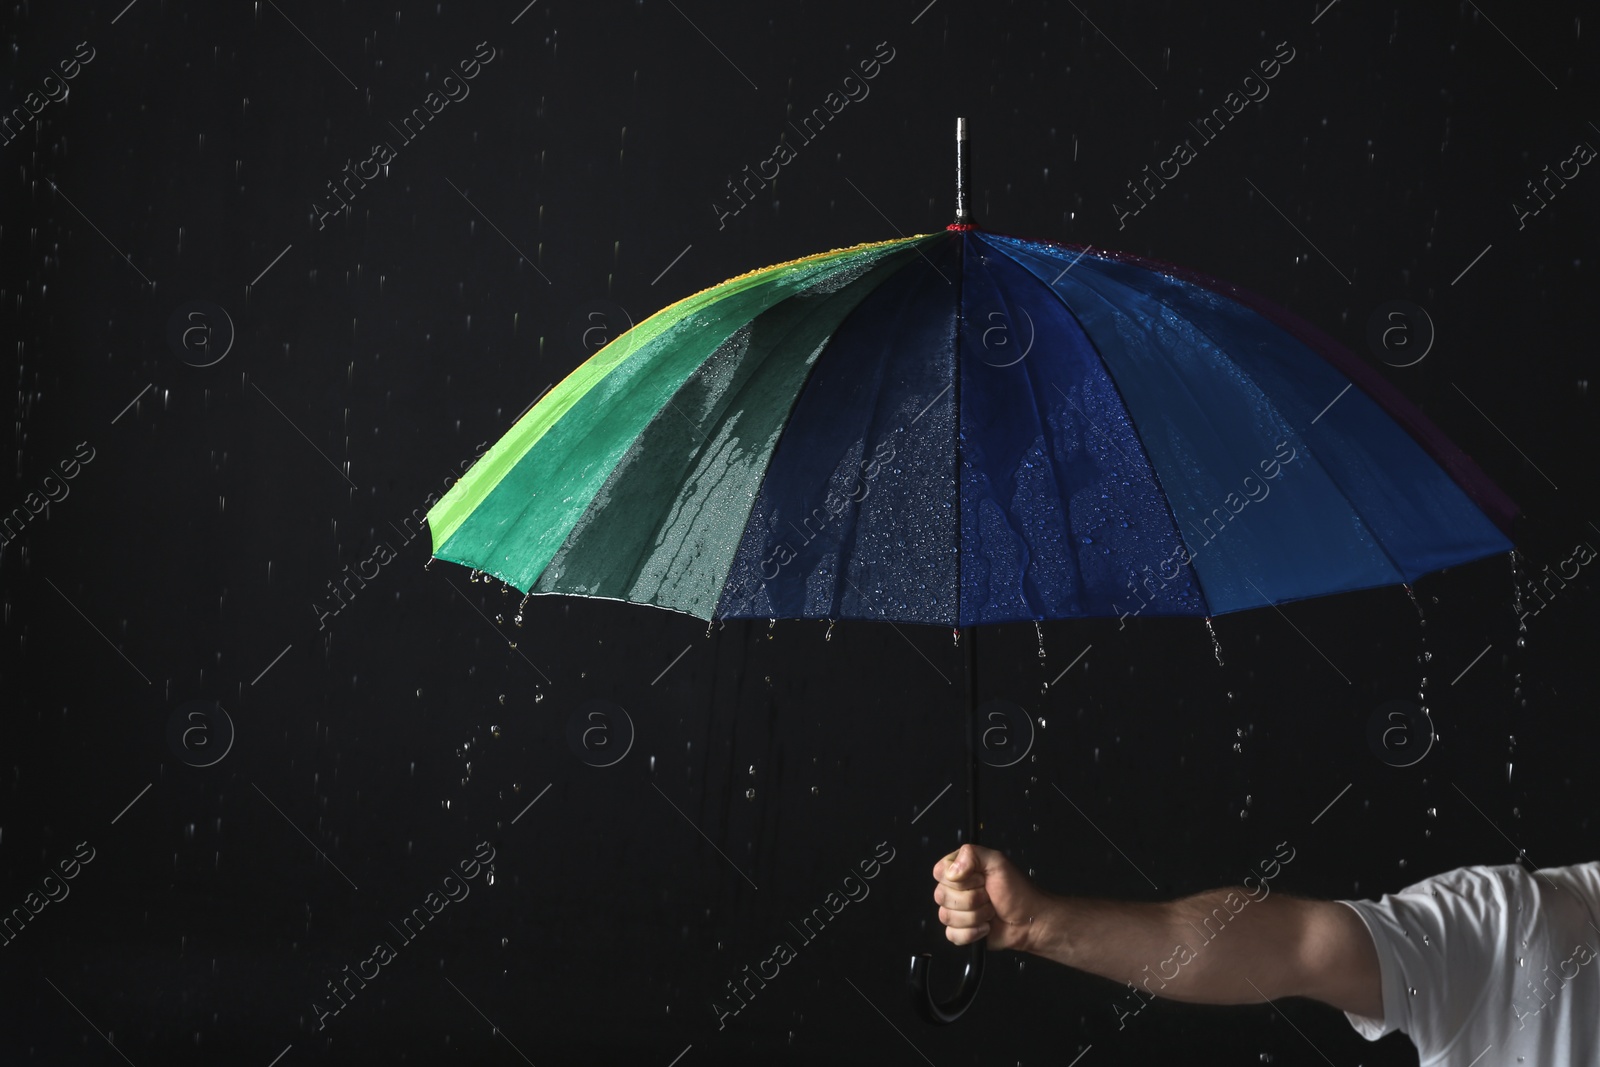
left=933, top=845, right=1051, bottom=952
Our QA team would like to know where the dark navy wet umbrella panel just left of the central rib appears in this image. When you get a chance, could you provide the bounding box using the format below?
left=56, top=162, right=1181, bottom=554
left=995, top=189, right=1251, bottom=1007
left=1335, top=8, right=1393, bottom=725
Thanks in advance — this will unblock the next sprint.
left=720, top=231, right=960, bottom=624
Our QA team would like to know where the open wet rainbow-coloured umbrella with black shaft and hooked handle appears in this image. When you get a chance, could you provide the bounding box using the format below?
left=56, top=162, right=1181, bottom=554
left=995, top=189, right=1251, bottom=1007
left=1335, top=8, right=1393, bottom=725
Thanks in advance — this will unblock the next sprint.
left=427, top=122, right=1515, bottom=1022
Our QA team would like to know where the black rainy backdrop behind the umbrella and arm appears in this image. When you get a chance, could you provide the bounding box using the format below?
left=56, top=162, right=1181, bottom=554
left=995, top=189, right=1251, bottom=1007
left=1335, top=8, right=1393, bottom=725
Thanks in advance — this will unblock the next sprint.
left=0, top=0, right=1600, bottom=1067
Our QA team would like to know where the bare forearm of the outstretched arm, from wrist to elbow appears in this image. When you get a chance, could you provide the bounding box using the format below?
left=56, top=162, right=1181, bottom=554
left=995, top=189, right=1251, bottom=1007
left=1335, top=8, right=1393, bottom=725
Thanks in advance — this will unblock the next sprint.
left=1029, top=886, right=1299, bottom=1005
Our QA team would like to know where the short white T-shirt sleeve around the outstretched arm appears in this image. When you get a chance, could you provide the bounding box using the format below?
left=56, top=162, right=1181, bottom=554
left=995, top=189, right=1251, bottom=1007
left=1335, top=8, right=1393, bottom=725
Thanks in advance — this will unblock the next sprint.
left=1339, top=864, right=1528, bottom=1064
